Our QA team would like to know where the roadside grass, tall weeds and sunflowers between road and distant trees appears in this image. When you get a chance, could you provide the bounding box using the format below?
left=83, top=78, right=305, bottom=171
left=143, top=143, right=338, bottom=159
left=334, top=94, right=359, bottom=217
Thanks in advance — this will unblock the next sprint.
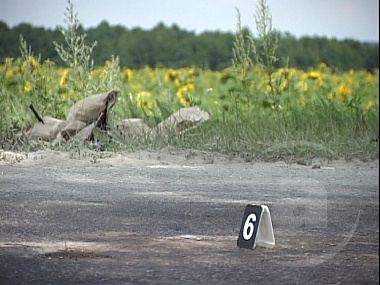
left=0, top=0, right=379, bottom=162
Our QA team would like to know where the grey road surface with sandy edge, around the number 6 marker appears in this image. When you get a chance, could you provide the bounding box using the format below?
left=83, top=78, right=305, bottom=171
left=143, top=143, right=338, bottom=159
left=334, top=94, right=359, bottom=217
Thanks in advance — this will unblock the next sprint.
left=0, top=151, right=379, bottom=285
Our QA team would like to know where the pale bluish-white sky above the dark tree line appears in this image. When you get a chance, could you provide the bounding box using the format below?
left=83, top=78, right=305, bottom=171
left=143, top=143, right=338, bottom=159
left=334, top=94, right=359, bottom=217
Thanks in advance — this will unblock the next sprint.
left=0, top=0, right=379, bottom=42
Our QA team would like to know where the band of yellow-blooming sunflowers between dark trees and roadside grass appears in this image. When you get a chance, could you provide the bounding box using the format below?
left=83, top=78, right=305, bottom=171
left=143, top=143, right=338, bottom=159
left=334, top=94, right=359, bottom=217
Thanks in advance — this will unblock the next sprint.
left=0, top=56, right=379, bottom=121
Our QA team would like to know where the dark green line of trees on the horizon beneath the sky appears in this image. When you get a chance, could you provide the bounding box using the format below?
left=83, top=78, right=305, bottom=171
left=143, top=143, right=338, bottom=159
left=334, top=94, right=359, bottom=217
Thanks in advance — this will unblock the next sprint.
left=0, top=21, right=379, bottom=71
